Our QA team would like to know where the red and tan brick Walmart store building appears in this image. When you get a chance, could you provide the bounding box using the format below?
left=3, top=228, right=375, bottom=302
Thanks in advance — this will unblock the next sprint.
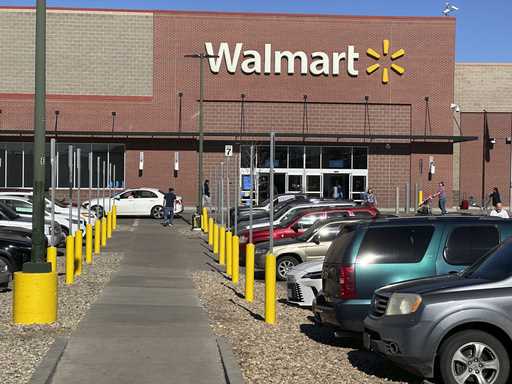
left=0, top=7, right=512, bottom=207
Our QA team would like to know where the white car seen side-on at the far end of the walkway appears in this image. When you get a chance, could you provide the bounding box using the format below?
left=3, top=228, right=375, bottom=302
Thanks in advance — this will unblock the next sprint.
left=82, top=188, right=183, bottom=219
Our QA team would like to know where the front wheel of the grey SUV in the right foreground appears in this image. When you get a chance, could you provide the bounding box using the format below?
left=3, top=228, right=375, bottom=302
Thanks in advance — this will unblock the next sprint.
left=439, top=330, right=510, bottom=384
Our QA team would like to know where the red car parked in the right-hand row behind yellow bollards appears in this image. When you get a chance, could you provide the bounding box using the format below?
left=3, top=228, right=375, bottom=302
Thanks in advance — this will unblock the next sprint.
left=240, top=207, right=379, bottom=250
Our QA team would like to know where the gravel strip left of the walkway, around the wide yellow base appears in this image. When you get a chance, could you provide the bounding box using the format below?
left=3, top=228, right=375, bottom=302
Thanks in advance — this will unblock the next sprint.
left=0, top=253, right=122, bottom=384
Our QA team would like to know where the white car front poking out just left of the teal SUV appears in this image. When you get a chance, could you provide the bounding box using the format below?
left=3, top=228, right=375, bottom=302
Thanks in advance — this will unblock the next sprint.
left=286, top=260, right=324, bottom=307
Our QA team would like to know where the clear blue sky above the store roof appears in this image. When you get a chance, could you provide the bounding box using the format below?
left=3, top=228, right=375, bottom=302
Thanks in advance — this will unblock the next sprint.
left=0, top=0, right=512, bottom=62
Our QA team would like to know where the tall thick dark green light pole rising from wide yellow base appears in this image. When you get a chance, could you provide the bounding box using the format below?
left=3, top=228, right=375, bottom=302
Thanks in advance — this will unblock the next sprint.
left=27, top=0, right=47, bottom=272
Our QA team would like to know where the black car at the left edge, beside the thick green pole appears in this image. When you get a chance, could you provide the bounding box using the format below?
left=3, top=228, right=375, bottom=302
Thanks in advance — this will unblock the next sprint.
left=0, top=226, right=35, bottom=286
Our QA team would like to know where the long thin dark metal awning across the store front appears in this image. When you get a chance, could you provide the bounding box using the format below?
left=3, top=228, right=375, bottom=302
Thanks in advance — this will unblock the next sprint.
left=0, top=129, right=478, bottom=143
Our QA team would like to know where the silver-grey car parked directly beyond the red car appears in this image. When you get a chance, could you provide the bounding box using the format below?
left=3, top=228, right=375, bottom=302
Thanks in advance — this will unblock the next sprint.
left=238, top=199, right=356, bottom=231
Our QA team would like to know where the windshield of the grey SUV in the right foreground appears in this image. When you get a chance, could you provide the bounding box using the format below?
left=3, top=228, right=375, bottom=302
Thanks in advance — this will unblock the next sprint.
left=462, top=239, right=512, bottom=281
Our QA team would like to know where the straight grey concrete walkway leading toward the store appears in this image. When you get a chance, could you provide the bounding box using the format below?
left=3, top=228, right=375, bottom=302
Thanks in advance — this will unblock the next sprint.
left=52, top=219, right=226, bottom=384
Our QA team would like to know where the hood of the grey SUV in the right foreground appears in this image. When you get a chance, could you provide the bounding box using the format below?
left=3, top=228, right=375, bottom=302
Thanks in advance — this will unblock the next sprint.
left=376, top=275, right=487, bottom=296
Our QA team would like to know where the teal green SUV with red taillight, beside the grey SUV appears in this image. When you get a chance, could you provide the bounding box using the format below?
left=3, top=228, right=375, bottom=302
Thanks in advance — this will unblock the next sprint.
left=313, top=216, right=512, bottom=334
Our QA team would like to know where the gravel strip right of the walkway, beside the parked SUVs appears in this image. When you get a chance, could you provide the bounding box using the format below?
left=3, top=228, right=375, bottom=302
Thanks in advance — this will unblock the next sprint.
left=193, top=270, right=421, bottom=384
